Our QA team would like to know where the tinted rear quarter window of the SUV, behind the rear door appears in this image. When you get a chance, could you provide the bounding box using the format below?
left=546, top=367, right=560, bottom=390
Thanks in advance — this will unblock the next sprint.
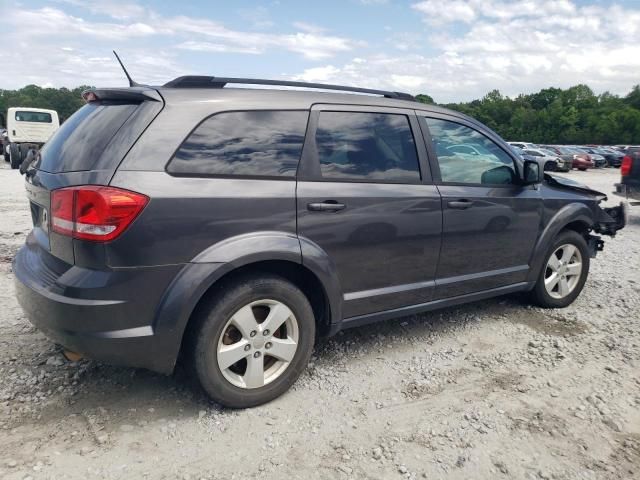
left=167, top=111, right=309, bottom=177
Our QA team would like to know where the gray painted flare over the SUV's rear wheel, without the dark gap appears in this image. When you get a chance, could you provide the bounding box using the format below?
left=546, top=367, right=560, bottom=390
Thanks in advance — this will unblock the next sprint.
left=153, top=232, right=342, bottom=370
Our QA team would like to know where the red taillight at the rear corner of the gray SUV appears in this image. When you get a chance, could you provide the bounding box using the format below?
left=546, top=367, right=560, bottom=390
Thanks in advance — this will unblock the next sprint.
left=51, top=185, right=149, bottom=242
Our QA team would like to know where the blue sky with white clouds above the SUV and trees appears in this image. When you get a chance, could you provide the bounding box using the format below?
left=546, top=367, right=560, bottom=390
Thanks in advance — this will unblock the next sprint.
left=0, top=0, right=640, bottom=103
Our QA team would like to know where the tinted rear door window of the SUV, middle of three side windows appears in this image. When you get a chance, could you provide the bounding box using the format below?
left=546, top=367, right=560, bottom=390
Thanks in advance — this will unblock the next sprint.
left=316, top=111, right=420, bottom=183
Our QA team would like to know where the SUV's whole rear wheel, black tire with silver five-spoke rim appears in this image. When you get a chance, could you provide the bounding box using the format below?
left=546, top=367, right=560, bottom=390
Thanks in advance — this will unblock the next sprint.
left=192, top=275, right=316, bottom=408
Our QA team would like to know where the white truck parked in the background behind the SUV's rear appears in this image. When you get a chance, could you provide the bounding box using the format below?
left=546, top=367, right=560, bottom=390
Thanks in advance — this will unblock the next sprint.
left=3, top=107, right=60, bottom=168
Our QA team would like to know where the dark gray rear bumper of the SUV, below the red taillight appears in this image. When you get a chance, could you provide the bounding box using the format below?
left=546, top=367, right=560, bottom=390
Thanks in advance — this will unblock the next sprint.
left=13, top=243, right=180, bottom=373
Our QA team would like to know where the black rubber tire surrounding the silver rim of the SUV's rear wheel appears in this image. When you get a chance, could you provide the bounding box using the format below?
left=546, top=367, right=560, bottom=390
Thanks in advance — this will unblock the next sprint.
left=191, top=274, right=316, bottom=408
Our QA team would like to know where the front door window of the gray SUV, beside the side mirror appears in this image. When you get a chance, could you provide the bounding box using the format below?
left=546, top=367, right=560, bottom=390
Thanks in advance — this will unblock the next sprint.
left=425, top=118, right=517, bottom=185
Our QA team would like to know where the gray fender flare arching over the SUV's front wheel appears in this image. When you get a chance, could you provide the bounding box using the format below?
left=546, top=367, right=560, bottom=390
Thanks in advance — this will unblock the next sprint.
left=527, top=203, right=593, bottom=285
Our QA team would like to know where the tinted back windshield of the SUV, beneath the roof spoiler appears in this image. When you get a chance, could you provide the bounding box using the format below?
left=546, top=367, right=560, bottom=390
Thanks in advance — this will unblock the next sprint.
left=37, top=102, right=138, bottom=173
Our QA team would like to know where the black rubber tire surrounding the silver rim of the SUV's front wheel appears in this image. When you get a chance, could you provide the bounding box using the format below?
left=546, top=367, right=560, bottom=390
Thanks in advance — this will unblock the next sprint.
left=531, top=230, right=590, bottom=308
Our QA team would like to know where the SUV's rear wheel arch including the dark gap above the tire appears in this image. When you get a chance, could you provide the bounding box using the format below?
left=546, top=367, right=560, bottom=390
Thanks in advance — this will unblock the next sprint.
left=154, top=232, right=342, bottom=374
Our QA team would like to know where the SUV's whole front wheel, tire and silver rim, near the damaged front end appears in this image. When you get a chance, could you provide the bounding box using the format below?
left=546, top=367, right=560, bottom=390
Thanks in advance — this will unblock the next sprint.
left=531, top=230, right=589, bottom=308
